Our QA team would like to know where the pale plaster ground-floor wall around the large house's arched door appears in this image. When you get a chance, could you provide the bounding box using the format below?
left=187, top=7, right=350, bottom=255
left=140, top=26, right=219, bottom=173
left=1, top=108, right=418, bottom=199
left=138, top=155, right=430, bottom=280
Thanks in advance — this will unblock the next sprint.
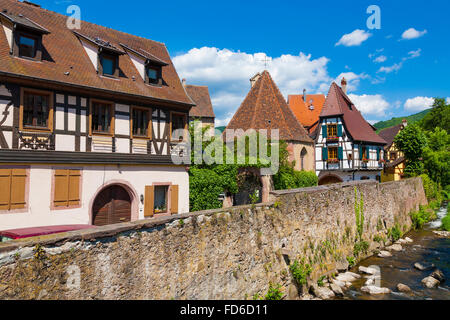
left=0, top=165, right=189, bottom=230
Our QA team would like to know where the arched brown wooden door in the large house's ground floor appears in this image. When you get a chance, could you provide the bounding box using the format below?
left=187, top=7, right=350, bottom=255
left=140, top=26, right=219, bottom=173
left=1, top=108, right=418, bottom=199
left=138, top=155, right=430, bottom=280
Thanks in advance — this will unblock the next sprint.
left=92, top=185, right=131, bottom=226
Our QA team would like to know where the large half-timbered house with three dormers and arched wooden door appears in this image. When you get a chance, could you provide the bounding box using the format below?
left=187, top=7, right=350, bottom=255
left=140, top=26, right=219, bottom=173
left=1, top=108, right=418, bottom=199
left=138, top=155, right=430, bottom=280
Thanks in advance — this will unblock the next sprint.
left=0, top=0, right=194, bottom=229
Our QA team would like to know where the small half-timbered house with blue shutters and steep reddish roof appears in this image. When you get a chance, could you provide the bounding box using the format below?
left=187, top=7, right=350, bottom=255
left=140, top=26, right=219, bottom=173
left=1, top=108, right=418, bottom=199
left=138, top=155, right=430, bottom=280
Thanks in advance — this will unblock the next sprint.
left=316, top=79, right=386, bottom=185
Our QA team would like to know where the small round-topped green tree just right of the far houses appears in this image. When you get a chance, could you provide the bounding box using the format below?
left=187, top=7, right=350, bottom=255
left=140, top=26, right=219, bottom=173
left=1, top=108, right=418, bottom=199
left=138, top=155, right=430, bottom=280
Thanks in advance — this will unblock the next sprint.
left=394, top=124, right=427, bottom=177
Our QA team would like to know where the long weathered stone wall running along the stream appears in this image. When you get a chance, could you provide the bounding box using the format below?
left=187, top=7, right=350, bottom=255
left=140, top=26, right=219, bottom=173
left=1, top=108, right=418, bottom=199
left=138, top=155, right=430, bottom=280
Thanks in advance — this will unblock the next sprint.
left=0, top=178, right=427, bottom=299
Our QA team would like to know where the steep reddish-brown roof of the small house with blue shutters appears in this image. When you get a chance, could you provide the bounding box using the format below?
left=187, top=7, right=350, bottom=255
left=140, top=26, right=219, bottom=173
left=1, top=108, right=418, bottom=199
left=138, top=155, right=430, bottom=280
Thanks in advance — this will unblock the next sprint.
left=320, top=82, right=386, bottom=145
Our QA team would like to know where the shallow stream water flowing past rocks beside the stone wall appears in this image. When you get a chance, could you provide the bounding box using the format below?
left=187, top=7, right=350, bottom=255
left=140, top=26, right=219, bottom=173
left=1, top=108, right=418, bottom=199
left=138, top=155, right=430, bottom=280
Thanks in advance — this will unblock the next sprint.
left=343, top=207, right=450, bottom=300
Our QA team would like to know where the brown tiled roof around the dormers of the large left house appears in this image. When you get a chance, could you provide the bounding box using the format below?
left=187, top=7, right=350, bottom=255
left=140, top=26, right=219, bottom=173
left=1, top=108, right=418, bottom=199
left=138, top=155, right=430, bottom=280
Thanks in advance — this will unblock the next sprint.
left=0, top=0, right=192, bottom=107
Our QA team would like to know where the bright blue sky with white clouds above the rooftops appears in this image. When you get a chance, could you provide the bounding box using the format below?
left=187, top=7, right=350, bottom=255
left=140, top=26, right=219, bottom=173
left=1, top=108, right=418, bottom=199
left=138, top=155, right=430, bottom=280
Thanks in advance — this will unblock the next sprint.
left=43, top=0, right=450, bottom=124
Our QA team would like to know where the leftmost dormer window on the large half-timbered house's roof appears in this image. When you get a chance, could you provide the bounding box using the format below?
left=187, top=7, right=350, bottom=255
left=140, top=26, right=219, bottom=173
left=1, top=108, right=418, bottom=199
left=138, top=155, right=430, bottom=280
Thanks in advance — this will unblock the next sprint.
left=0, top=12, right=50, bottom=61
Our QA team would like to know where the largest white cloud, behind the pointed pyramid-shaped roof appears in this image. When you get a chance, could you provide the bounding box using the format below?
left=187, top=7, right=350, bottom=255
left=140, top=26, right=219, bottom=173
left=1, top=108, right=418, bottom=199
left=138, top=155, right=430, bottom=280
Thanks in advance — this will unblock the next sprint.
left=173, top=47, right=334, bottom=123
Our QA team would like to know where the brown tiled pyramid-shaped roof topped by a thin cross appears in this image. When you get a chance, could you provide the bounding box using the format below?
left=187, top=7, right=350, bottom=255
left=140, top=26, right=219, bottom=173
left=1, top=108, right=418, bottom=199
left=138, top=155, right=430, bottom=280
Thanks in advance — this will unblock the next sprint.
left=227, top=71, right=313, bottom=143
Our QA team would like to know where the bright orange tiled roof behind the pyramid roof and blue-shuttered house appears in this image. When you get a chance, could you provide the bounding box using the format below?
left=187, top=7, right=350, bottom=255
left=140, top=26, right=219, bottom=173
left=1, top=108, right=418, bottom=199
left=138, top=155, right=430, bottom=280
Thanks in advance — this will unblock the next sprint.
left=288, top=94, right=326, bottom=127
